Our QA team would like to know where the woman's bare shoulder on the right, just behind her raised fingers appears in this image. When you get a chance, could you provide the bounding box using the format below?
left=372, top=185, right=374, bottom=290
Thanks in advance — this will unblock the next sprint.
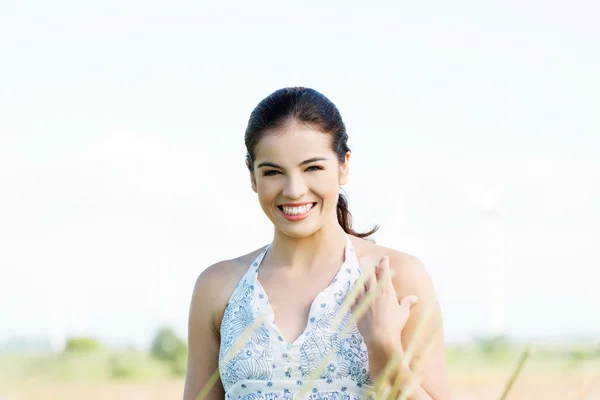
left=346, top=238, right=435, bottom=298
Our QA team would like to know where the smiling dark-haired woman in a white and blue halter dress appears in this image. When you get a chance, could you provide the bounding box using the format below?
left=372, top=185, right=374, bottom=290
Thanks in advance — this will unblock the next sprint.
left=184, top=87, right=450, bottom=400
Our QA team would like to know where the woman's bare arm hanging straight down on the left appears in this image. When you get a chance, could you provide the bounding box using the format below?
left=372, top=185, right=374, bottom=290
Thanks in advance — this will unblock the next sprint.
left=183, top=265, right=225, bottom=400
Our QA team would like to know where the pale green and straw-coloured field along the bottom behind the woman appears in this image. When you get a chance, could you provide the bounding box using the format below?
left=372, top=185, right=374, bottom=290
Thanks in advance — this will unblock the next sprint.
left=0, top=348, right=600, bottom=400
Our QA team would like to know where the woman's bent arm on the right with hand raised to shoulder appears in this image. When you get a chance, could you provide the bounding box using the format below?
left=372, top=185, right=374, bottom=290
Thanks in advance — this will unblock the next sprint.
left=355, top=248, right=451, bottom=400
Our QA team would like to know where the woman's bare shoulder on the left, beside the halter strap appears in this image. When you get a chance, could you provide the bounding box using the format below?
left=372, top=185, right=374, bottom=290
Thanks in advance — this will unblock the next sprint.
left=192, top=247, right=264, bottom=334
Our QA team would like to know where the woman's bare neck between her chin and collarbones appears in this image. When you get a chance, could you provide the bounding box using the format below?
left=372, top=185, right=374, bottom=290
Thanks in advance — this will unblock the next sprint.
left=269, top=219, right=346, bottom=271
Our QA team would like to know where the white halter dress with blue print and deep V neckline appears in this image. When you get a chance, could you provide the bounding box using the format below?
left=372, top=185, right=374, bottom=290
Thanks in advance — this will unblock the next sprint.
left=219, top=236, right=372, bottom=400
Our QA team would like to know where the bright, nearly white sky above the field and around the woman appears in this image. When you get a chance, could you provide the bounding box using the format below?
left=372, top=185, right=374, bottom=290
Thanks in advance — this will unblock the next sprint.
left=0, top=0, right=600, bottom=346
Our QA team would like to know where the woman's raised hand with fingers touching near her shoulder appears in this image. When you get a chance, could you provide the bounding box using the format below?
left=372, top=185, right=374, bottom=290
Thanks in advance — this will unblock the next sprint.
left=351, top=257, right=418, bottom=353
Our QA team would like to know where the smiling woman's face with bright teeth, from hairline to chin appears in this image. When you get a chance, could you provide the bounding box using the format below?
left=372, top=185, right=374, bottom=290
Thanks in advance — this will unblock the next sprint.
left=251, top=123, right=350, bottom=237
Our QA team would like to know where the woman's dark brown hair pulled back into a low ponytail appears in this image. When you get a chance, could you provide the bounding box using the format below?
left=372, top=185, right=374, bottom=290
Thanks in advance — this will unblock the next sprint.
left=244, top=87, right=379, bottom=238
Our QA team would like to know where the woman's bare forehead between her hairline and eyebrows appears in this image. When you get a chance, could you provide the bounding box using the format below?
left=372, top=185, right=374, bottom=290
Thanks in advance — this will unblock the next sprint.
left=255, top=124, right=335, bottom=164
